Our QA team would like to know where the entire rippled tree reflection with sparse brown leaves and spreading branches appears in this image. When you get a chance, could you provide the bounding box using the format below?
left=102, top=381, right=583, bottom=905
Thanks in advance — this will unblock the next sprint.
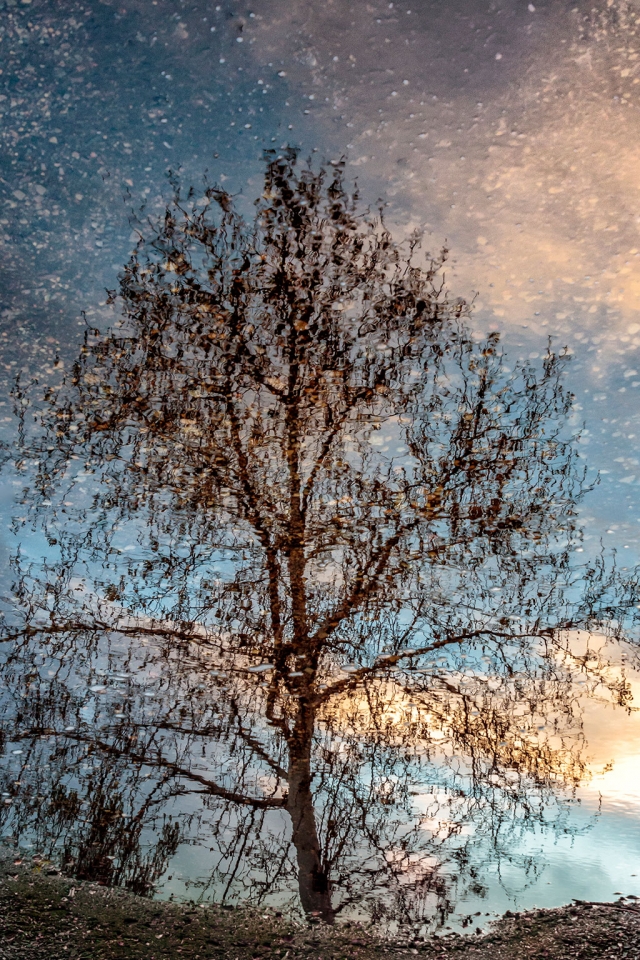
left=2, top=154, right=634, bottom=922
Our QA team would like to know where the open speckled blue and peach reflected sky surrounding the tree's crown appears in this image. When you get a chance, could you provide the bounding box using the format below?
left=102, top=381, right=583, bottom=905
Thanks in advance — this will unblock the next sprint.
left=0, top=0, right=640, bottom=936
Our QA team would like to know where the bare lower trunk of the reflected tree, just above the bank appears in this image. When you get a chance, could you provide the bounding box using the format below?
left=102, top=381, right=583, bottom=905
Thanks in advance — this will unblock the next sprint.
left=287, top=724, right=335, bottom=923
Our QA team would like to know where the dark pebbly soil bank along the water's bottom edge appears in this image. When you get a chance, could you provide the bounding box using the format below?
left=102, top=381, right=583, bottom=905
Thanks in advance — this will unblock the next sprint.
left=0, top=859, right=640, bottom=960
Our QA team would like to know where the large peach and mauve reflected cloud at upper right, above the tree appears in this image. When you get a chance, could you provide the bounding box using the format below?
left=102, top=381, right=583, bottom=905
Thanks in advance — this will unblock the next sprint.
left=246, top=2, right=640, bottom=340
